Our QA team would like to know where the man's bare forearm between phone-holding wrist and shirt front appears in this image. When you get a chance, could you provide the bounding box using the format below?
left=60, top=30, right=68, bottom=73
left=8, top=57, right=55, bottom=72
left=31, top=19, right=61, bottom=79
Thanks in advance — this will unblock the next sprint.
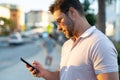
left=43, top=71, right=60, bottom=80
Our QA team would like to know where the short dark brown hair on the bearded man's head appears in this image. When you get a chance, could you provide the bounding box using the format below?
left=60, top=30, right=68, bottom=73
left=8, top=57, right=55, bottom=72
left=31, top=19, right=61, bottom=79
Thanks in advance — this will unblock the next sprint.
left=49, top=0, right=84, bottom=16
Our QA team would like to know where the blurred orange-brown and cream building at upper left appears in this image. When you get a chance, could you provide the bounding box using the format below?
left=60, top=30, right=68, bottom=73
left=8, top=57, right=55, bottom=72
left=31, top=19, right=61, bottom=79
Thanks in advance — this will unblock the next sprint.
left=0, top=4, right=25, bottom=32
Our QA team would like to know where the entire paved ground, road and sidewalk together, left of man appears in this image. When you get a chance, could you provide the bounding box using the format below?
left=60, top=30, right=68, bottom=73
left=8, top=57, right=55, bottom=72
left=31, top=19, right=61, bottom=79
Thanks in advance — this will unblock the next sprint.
left=0, top=40, right=61, bottom=80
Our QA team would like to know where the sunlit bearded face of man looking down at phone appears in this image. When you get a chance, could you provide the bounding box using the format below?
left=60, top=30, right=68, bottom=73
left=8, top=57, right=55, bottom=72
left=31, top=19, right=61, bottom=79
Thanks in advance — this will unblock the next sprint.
left=53, top=10, right=74, bottom=38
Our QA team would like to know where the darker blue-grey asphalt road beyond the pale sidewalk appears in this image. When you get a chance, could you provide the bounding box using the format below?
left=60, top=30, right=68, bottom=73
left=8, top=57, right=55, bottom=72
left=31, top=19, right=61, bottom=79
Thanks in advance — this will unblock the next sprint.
left=0, top=39, right=41, bottom=70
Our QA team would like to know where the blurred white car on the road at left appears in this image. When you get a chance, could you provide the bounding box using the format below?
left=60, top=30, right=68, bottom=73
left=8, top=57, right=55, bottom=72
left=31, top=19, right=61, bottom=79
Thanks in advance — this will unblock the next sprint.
left=8, top=33, right=23, bottom=45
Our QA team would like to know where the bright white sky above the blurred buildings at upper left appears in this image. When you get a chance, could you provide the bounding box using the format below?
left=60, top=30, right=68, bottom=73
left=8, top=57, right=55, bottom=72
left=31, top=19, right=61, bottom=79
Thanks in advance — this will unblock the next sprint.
left=0, top=0, right=54, bottom=12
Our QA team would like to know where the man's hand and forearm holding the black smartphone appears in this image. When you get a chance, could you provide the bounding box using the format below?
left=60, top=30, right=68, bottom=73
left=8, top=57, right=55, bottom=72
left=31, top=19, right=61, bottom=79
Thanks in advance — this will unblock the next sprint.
left=26, top=61, right=60, bottom=80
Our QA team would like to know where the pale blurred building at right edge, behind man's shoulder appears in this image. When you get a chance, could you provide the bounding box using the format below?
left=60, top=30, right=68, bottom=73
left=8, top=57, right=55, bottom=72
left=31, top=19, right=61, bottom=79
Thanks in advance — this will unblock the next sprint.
left=106, top=0, right=120, bottom=42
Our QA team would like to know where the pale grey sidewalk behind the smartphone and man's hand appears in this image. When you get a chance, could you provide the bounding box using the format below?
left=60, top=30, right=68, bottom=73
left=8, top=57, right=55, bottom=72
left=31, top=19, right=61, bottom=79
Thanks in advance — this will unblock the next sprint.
left=0, top=45, right=61, bottom=80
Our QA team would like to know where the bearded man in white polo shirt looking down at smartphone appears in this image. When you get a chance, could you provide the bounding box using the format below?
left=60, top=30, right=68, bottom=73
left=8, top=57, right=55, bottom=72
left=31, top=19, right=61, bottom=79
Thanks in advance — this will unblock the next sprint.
left=25, top=0, right=119, bottom=80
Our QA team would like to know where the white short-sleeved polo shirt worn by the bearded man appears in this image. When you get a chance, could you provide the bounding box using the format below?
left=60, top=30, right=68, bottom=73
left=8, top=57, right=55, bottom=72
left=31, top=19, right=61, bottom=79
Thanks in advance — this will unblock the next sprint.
left=60, top=26, right=118, bottom=80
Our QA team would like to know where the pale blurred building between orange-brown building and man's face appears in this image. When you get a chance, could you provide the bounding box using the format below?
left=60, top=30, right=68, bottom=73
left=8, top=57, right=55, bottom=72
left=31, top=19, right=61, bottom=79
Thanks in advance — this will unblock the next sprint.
left=25, top=10, right=54, bottom=29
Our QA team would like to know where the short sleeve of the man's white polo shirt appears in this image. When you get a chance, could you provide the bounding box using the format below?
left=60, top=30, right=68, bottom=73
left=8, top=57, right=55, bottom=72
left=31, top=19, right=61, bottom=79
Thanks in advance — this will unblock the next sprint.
left=91, top=40, right=118, bottom=74
